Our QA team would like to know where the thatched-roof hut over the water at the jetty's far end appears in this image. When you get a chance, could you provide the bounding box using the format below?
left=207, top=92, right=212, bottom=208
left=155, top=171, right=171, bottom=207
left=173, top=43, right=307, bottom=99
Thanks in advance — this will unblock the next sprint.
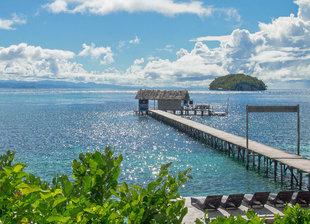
left=135, top=89, right=190, bottom=113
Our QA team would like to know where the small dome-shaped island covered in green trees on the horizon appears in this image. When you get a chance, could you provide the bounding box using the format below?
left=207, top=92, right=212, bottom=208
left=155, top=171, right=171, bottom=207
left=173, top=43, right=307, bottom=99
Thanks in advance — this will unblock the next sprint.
left=209, top=74, right=267, bottom=91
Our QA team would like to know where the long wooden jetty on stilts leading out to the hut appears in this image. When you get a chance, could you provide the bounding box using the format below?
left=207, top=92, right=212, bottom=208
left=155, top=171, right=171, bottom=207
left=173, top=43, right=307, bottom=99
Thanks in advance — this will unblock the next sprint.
left=148, top=110, right=310, bottom=190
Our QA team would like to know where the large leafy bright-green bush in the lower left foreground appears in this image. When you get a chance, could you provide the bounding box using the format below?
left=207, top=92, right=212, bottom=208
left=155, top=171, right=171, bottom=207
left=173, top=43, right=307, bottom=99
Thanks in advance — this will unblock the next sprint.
left=0, top=147, right=192, bottom=223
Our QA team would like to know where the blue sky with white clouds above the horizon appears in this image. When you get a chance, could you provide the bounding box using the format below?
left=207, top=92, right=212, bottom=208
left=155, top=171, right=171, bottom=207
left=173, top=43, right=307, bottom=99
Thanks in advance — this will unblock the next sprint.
left=0, top=0, right=310, bottom=89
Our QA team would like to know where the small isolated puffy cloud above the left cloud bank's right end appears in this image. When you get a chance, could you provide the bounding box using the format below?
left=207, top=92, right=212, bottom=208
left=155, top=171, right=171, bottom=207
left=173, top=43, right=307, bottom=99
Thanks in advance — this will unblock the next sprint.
left=79, top=43, right=114, bottom=65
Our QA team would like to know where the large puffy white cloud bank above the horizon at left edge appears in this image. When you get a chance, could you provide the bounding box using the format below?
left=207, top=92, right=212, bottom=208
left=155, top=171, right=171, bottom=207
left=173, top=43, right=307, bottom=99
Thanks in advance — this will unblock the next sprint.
left=0, top=43, right=85, bottom=81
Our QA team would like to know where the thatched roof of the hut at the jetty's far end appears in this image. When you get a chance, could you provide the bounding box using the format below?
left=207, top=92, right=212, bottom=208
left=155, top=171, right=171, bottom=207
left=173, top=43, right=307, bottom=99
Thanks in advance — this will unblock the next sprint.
left=135, top=89, right=189, bottom=100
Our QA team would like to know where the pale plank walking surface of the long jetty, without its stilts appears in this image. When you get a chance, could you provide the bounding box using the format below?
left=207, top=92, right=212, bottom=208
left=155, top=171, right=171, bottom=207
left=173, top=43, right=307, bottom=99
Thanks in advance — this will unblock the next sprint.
left=150, top=110, right=310, bottom=174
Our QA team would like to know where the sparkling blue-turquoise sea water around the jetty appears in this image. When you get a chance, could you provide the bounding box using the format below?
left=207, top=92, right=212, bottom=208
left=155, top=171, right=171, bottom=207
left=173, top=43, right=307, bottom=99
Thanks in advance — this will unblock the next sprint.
left=0, top=89, right=310, bottom=196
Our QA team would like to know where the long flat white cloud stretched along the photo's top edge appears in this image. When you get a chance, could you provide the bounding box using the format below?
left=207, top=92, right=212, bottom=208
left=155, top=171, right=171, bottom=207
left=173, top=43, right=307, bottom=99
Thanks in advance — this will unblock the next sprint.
left=45, top=0, right=239, bottom=19
